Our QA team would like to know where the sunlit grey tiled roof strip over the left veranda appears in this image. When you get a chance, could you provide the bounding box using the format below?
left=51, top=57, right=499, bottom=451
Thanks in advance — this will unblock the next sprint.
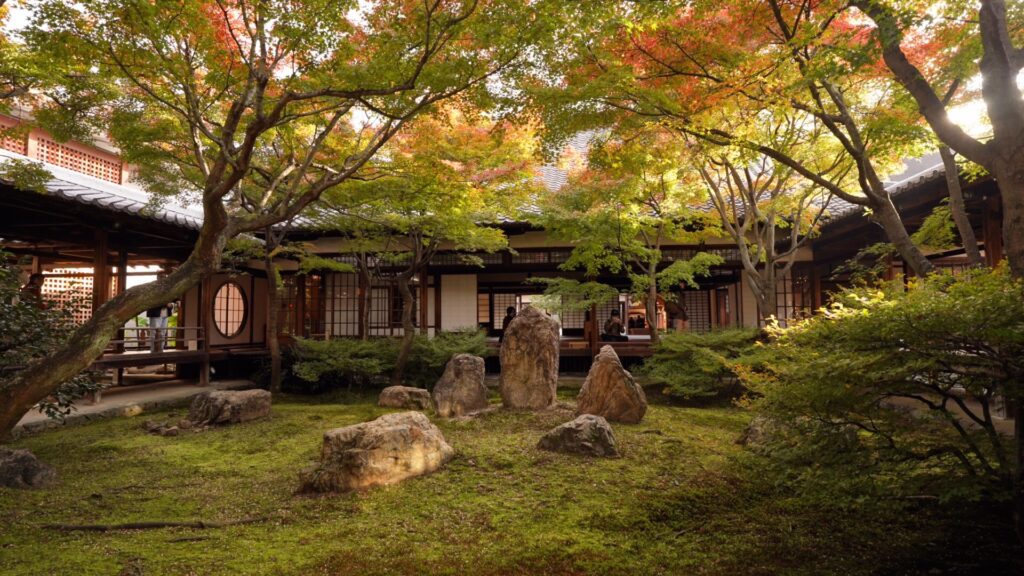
left=0, top=150, right=203, bottom=230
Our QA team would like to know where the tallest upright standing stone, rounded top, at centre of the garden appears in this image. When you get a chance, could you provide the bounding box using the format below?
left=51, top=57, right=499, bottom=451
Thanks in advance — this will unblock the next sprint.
left=500, top=306, right=558, bottom=410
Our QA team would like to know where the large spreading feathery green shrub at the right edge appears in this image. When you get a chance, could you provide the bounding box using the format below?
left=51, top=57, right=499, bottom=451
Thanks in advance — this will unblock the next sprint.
left=735, top=266, right=1024, bottom=534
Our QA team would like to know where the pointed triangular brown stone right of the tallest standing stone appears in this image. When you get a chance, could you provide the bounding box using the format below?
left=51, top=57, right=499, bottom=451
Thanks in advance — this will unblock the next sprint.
left=577, top=345, right=647, bottom=424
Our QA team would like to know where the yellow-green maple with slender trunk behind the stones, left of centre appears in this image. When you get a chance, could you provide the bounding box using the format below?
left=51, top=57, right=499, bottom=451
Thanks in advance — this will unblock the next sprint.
left=315, top=108, right=537, bottom=385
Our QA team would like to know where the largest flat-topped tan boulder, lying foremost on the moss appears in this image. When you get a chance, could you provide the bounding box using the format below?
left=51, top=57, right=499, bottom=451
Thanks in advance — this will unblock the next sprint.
left=300, top=412, right=455, bottom=492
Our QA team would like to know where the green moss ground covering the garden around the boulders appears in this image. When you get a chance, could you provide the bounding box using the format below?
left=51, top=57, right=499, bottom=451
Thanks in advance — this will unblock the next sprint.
left=0, top=393, right=1005, bottom=576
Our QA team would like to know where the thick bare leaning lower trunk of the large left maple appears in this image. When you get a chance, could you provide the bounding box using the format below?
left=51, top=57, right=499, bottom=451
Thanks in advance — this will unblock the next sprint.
left=0, top=205, right=228, bottom=440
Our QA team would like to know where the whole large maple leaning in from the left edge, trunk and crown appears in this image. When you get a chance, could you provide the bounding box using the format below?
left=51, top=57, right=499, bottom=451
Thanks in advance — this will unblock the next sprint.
left=0, top=0, right=566, bottom=435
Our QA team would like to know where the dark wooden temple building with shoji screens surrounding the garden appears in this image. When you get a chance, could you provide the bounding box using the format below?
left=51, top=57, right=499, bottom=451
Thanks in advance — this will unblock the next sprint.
left=0, top=117, right=1002, bottom=379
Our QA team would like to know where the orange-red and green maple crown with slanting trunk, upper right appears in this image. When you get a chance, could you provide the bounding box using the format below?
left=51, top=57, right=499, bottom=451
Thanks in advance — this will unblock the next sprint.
left=540, top=0, right=934, bottom=274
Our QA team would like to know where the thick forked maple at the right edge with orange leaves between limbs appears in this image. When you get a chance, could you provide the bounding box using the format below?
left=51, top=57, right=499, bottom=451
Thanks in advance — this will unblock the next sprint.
left=851, top=0, right=1024, bottom=277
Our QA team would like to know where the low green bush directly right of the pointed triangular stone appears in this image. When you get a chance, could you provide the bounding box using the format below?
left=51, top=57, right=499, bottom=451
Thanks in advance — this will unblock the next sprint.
left=639, top=328, right=760, bottom=400
